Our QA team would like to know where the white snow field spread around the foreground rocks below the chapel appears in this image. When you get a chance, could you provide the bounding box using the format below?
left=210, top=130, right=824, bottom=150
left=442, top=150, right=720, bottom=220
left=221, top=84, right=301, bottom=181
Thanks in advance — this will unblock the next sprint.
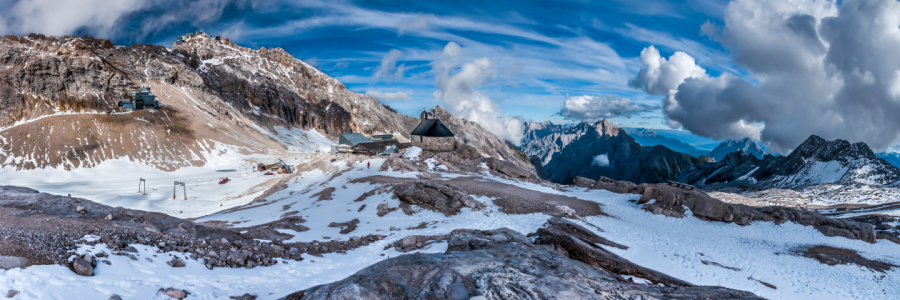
left=0, top=152, right=900, bottom=300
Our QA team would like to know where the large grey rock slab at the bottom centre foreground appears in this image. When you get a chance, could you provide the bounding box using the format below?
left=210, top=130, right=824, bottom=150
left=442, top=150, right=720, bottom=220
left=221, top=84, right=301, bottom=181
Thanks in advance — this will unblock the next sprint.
left=284, top=219, right=762, bottom=300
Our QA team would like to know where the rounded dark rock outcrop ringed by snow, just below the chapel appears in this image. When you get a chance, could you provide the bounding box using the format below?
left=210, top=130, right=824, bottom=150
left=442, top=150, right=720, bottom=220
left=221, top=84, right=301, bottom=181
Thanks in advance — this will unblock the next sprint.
left=394, top=181, right=484, bottom=216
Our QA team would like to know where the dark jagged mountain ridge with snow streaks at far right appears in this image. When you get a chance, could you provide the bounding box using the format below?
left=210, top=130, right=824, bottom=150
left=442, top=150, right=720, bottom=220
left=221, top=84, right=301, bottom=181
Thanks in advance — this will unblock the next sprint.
left=678, top=135, right=900, bottom=188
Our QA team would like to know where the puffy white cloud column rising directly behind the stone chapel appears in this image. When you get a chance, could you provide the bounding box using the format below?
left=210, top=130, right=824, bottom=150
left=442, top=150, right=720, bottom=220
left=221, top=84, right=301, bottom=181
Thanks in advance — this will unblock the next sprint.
left=432, top=42, right=524, bottom=145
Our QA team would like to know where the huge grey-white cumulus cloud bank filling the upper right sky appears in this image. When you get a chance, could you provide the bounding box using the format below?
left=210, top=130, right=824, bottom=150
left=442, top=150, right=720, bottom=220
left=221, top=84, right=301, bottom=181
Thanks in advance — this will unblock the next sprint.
left=632, top=0, right=900, bottom=153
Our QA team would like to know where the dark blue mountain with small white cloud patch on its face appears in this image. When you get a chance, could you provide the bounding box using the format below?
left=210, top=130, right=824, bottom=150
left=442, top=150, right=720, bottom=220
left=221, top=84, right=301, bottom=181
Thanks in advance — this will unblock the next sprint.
left=524, top=120, right=706, bottom=184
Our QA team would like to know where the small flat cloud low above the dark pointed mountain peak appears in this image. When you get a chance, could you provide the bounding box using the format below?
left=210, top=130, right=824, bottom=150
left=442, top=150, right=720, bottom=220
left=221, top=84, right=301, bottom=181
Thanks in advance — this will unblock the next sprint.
left=559, top=95, right=659, bottom=122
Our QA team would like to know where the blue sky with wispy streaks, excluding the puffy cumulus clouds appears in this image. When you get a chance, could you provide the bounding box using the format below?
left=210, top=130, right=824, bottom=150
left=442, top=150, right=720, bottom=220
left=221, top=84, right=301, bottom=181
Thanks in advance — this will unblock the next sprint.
left=40, top=0, right=733, bottom=128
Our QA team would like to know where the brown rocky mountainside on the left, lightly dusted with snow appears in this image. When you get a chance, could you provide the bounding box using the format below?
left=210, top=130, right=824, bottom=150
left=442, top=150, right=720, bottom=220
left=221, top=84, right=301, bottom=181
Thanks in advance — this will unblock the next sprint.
left=0, top=34, right=416, bottom=169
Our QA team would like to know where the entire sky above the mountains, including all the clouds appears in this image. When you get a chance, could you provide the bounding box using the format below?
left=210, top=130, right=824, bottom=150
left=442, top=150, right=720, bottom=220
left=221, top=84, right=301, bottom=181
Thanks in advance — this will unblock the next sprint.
left=0, top=0, right=900, bottom=153
